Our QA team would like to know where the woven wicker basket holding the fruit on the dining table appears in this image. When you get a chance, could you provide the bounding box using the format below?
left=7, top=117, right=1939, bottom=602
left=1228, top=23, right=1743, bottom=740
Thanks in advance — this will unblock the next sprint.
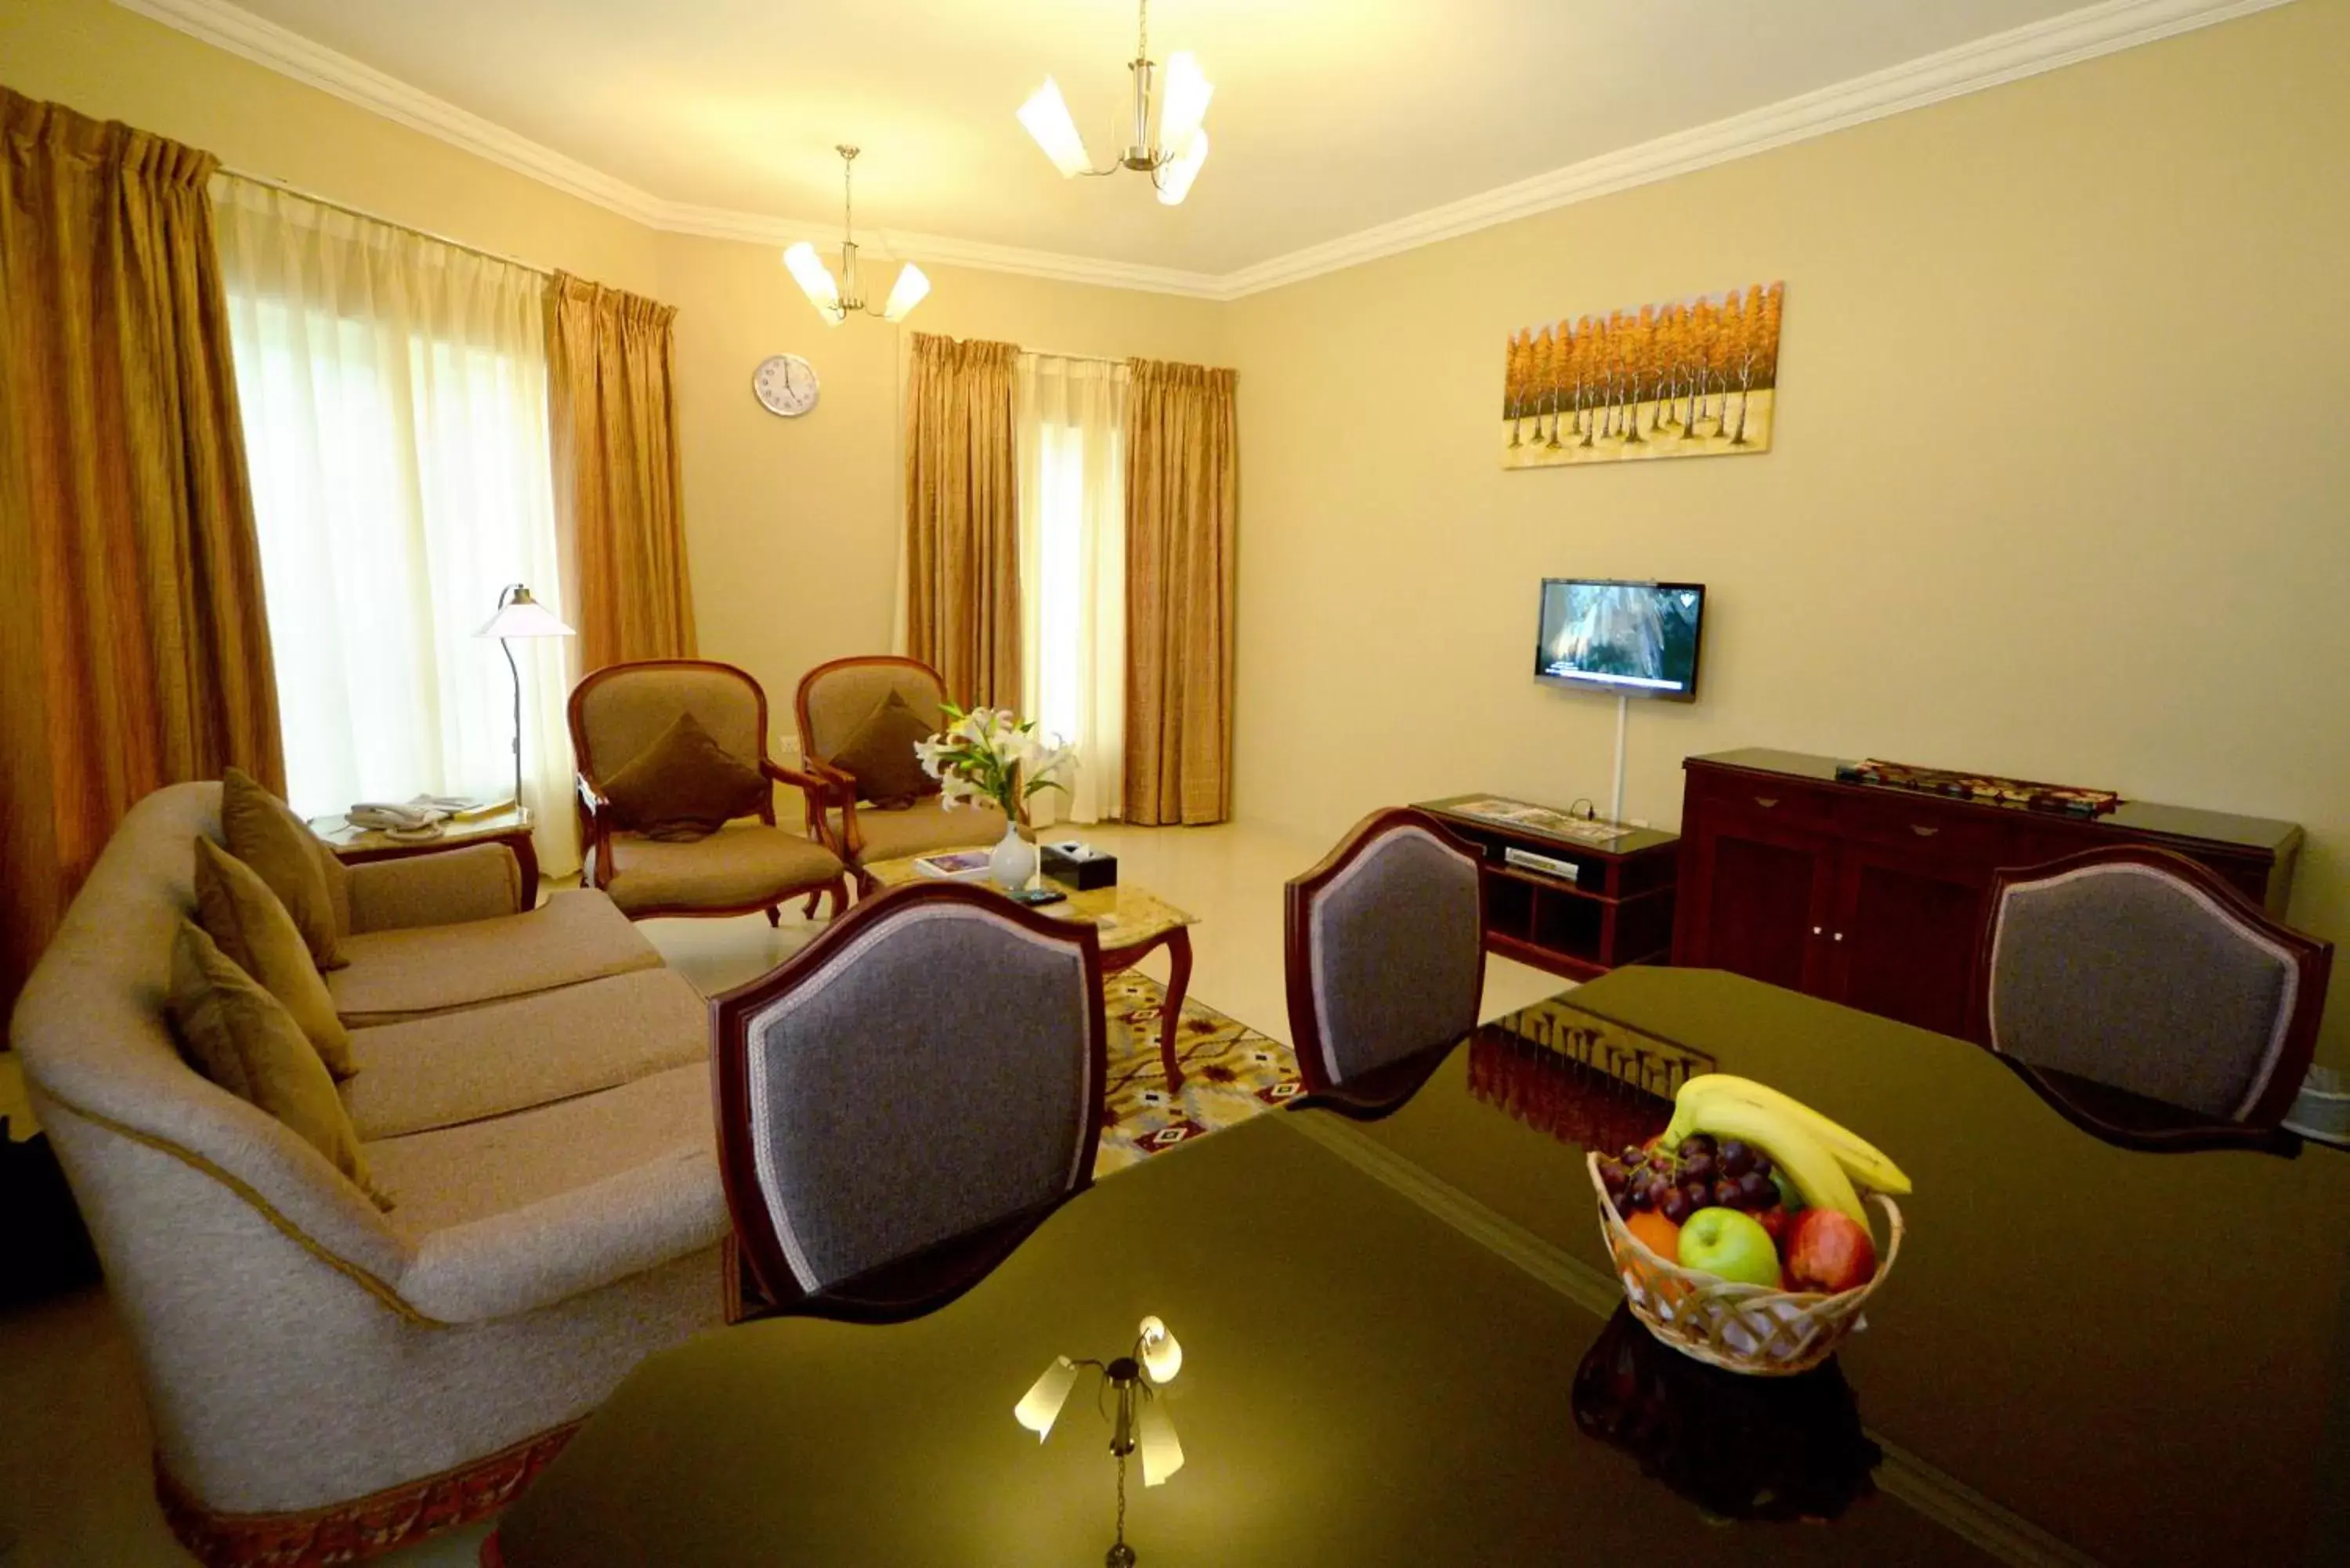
left=1589, top=1154, right=1901, bottom=1378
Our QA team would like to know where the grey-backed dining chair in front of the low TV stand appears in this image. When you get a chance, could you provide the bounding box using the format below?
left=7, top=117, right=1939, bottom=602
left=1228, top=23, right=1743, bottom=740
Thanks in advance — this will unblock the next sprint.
left=1285, top=807, right=1485, bottom=1119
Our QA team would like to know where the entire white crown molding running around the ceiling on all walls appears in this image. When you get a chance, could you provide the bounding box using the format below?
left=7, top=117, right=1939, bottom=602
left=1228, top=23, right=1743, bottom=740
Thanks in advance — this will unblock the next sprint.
left=115, top=0, right=2291, bottom=301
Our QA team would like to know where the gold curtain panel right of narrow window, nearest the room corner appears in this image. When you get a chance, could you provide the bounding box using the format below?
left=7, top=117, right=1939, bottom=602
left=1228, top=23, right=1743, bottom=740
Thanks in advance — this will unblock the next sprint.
left=1126, top=359, right=1241, bottom=823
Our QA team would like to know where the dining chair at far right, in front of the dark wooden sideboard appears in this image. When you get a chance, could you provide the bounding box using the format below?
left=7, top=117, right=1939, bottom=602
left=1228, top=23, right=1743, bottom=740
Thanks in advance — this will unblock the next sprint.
left=1974, top=844, right=2334, bottom=1147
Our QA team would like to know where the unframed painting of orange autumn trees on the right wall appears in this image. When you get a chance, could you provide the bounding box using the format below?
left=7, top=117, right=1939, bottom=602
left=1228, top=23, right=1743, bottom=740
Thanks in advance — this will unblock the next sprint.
left=1502, top=282, right=1786, bottom=468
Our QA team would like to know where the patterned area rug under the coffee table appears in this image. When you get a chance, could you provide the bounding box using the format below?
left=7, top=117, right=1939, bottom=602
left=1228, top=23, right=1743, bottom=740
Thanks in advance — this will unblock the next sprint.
left=1093, top=971, right=1297, bottom=1178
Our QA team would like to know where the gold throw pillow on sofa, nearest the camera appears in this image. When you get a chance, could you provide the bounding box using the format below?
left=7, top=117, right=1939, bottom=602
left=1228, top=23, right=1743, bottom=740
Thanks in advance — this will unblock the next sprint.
left=172, top=919, right=392, bottom=1209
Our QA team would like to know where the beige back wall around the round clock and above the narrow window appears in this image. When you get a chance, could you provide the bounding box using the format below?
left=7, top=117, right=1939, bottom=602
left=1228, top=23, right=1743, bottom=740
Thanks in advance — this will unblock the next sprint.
left=660, top=235, right=1222, bottom=735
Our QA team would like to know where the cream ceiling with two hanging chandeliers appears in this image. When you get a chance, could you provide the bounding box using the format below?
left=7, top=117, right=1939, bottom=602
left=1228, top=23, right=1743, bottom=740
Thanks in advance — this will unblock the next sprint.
left=183, top=0, right=2214, bottom=275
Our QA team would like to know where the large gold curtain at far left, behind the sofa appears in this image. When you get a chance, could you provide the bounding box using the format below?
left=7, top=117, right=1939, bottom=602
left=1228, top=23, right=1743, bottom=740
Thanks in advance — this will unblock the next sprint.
left=0, top=87, right=284, bottom=1006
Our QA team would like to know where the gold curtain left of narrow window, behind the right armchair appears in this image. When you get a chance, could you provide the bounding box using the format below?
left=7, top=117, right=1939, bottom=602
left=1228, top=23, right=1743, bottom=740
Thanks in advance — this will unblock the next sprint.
left=905, top=331, right=1020, bottom=707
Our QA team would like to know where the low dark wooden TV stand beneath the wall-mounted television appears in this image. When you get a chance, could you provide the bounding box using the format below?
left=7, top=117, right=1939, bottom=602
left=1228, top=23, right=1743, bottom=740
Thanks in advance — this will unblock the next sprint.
left=1419, top=795, right=1680, bottom=981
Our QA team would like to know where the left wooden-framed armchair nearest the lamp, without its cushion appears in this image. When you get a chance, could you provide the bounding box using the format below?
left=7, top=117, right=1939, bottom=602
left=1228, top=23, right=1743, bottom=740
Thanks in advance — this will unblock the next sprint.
left=571, top=658, right=848, bottom=924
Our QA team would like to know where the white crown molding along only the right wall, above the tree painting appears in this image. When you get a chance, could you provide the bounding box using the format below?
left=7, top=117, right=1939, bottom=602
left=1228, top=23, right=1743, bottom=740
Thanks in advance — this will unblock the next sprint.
left=1222, top=0, right=2289, bottom=298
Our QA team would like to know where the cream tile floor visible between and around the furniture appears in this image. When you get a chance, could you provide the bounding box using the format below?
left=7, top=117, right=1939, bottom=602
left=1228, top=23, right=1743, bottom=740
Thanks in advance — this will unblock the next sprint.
left=0, top=823, right=1560, bottom=1568
